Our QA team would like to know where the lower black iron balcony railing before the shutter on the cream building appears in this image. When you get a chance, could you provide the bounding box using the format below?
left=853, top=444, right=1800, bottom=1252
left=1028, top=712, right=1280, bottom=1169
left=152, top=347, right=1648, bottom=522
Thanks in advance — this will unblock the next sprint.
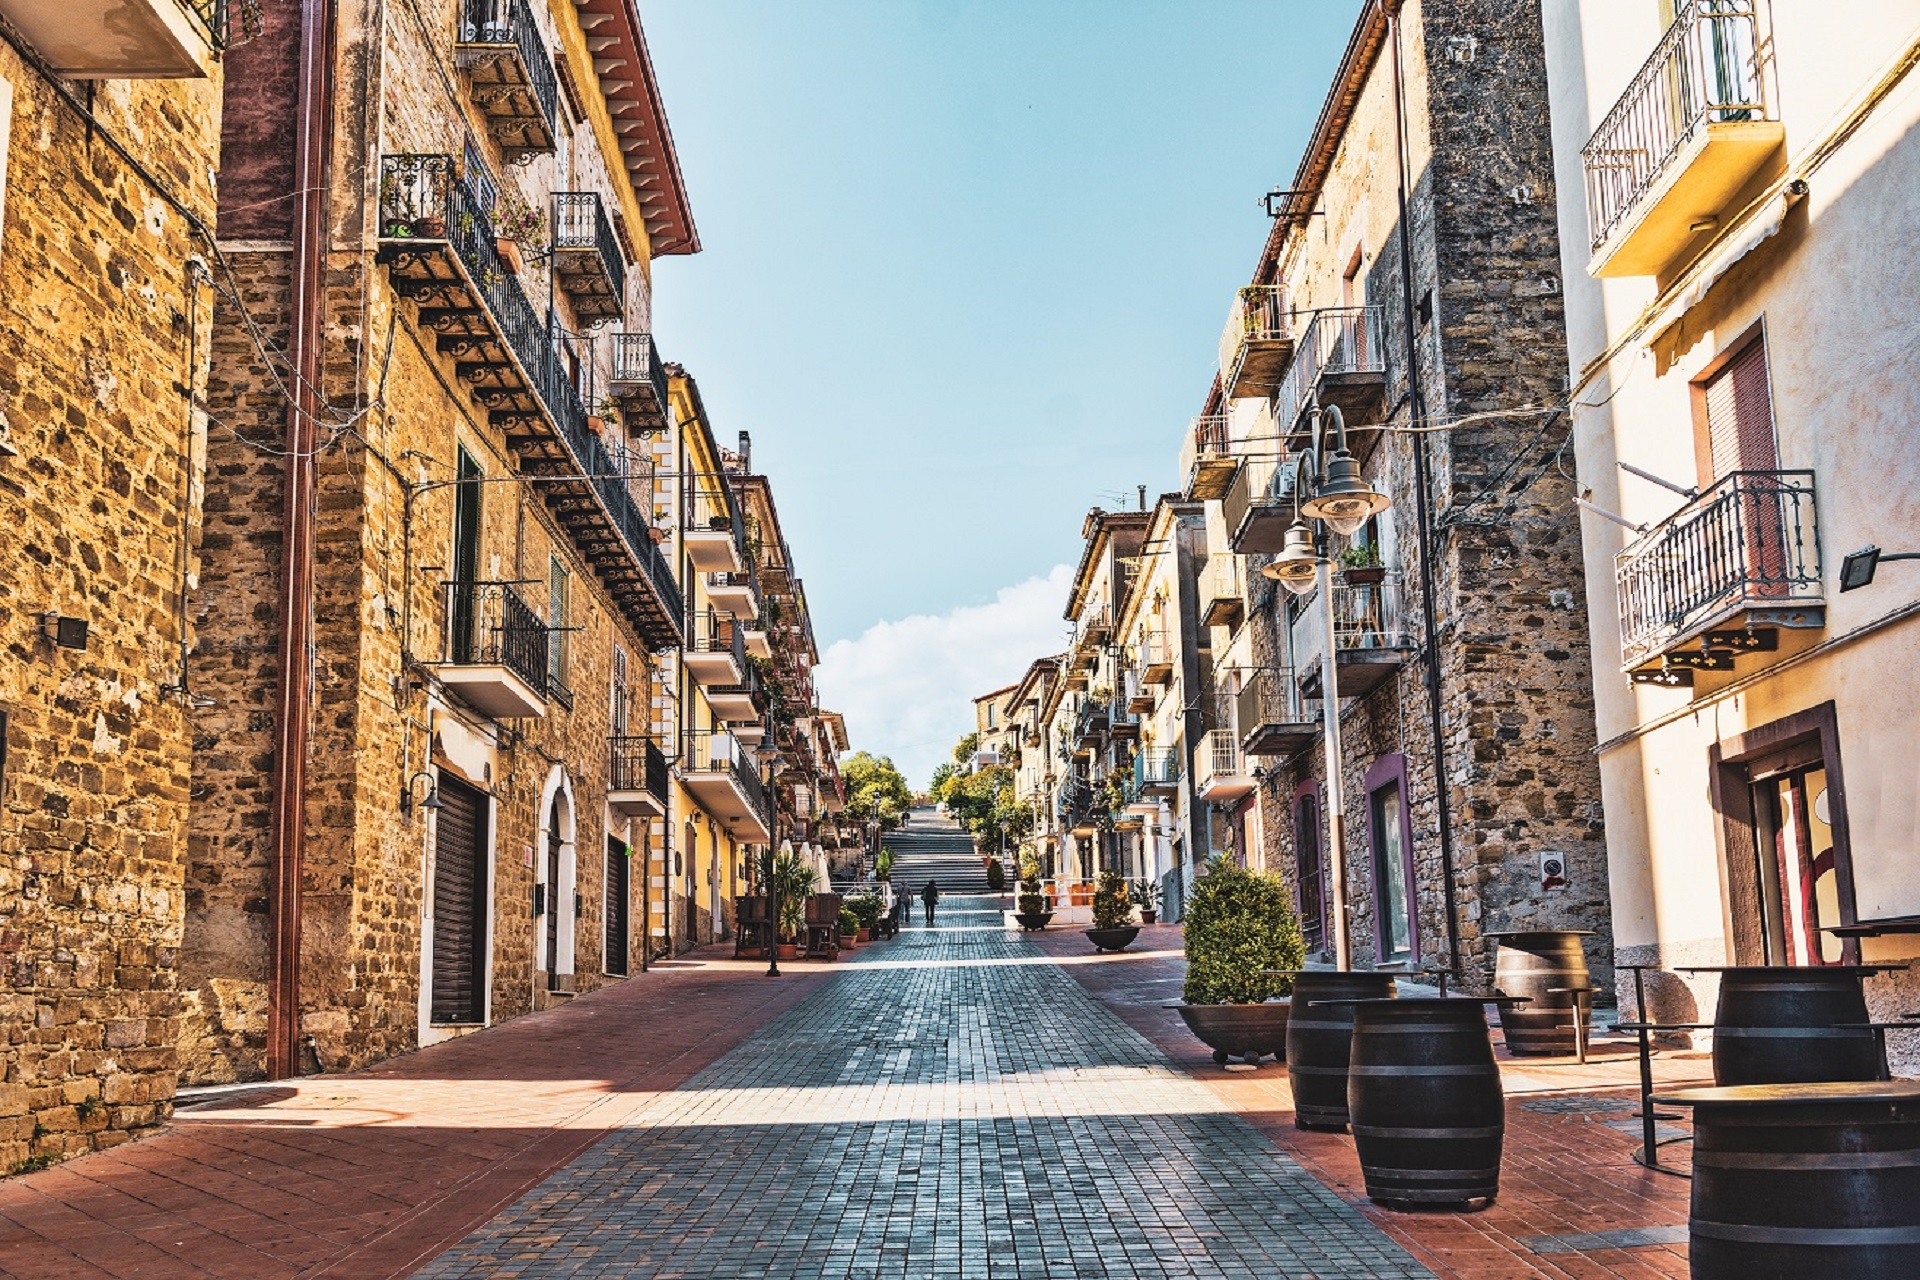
left=1613, top=470, right=1824, bottom=668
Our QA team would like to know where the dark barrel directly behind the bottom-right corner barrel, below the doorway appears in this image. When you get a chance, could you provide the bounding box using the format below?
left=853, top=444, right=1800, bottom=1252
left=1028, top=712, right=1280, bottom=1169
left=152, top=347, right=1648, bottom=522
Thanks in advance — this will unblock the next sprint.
left=1713, top=965, right=1873, bottom=1090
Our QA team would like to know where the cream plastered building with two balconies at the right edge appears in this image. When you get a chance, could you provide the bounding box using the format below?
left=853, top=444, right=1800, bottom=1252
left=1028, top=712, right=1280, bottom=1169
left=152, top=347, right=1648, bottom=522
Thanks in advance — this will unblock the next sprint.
left=1546, top=0, right=1920, bottom=1075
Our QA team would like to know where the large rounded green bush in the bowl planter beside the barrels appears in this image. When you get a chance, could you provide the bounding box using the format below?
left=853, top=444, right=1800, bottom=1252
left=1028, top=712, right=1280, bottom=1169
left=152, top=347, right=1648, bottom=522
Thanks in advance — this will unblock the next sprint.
left=1181, top=854, right=1306, bottom=1004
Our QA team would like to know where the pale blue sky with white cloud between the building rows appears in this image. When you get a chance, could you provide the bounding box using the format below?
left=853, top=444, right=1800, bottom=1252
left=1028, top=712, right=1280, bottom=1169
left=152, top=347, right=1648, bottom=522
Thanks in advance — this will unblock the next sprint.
left=641, top=0, right=1359, bottom=781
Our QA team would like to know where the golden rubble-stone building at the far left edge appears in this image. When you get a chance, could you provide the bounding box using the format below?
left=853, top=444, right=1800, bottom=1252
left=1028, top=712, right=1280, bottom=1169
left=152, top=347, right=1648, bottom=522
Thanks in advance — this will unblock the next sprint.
left=0, top=0, right=234, bottom=1174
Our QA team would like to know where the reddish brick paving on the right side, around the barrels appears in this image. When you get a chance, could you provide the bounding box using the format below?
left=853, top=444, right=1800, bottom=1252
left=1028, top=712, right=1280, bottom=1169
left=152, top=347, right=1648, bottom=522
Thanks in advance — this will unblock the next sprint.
left=1039, top=925, right=1713, bottom=1280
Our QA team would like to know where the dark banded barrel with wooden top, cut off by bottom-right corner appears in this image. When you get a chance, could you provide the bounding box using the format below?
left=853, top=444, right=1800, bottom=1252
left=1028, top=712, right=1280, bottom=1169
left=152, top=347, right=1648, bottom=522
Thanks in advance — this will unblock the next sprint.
left=1657, top=1080, right=1920, bottom=1280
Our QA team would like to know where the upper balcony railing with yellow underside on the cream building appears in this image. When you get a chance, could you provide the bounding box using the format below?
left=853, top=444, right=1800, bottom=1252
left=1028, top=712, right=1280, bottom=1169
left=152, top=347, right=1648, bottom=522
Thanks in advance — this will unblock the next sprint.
left=1580, top=0, right=1768, bottom=251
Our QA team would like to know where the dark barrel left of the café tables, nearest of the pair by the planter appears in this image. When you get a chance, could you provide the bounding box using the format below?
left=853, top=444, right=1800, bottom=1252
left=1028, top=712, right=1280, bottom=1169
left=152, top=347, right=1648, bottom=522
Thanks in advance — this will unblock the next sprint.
left=1346, top=996, right=1507, bottom=1207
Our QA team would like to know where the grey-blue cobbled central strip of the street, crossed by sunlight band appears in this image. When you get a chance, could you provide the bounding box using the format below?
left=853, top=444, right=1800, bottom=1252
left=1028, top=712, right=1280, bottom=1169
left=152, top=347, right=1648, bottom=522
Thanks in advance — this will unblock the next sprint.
left=419, top=898, right=1430, bottom=1280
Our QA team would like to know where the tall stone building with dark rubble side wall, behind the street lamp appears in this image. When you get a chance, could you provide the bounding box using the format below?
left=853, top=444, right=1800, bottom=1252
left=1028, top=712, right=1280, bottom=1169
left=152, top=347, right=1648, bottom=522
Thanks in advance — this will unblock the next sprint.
left=1183, top=0, right=1609, bottom=979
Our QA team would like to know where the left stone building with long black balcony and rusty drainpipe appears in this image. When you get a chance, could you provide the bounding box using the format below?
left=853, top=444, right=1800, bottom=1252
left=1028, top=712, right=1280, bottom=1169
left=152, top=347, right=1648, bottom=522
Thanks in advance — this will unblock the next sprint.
left=180, top=0, right=697, bottom=1080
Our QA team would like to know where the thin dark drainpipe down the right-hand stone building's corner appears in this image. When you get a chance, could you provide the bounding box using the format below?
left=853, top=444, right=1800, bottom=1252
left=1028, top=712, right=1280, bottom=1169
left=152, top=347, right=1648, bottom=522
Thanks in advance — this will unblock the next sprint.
left=1386, top=0, right=1459, bottom=975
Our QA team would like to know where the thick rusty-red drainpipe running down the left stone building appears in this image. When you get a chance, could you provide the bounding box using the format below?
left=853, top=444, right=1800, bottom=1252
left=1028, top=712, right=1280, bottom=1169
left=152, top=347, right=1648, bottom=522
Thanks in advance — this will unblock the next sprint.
left=267, top=0, right=334, bottom=1080
